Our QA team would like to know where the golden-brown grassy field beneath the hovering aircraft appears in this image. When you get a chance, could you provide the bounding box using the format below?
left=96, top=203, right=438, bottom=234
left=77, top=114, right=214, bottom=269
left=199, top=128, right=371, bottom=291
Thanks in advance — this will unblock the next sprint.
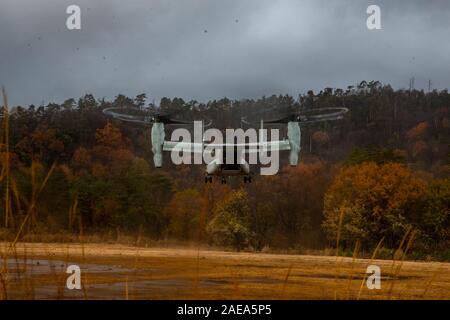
left=0, top=243, right=450, bottom=299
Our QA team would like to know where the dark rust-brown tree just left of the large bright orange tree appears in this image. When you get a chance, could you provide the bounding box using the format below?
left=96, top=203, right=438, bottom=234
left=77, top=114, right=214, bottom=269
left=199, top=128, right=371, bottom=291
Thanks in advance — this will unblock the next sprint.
left=250, top=160, right=332, bottom=248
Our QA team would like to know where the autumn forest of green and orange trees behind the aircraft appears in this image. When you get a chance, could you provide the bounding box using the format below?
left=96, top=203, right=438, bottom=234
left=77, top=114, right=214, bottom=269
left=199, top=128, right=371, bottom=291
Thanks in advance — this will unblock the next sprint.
left=0, top=81, right=450, bottom=259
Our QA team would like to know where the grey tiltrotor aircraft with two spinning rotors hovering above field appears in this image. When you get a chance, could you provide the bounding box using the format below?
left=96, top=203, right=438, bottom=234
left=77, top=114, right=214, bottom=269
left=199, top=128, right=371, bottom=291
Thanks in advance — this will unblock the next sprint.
left=103, top=108, right=348, bottom=183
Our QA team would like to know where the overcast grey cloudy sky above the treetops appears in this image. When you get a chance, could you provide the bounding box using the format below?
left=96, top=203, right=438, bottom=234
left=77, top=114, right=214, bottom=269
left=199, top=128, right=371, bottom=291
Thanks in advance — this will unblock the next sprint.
left=0, top=0, right=450, bottom=105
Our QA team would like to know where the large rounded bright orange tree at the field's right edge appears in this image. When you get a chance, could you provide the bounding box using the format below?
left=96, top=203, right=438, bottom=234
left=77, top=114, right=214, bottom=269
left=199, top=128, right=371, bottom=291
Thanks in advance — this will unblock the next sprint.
left=323, top=162, right=427, bottom=243
